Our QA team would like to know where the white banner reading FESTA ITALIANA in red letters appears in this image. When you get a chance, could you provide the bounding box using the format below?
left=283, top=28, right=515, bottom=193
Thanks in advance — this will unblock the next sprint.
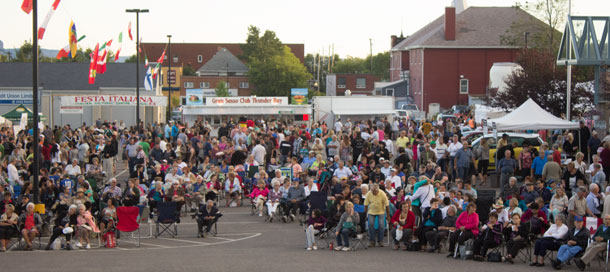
left=61, top=95, right=167, bottom=107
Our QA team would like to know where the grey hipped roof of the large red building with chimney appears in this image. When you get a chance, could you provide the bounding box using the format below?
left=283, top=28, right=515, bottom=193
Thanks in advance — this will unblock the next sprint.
left=392, top=7, right=546, bottom=51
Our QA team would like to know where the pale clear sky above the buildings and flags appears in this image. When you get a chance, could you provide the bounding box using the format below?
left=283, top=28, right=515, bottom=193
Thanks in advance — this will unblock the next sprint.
left=0, top=0, right=610, bottom=58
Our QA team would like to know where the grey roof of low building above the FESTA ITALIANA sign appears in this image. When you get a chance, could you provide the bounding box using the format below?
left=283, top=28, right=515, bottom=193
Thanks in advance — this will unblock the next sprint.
left=0, top=62, right=146, bottom=91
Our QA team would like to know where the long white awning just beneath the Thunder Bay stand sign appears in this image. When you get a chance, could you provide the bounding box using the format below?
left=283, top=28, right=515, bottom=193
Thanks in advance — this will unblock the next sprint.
left=182, top=105, right=312, bottom=115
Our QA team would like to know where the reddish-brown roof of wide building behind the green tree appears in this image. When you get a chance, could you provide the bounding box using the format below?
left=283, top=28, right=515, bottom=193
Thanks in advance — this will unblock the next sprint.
left=141, top=43, right=305, bottom=70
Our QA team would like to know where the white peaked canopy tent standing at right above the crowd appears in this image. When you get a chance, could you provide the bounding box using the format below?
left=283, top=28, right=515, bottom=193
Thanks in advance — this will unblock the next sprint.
left=487, top=98, right=579, bottom=131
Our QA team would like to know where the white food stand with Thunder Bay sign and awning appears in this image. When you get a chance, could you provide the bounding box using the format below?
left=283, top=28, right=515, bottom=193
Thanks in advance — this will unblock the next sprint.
left=182, top=96, right=312, bottom=127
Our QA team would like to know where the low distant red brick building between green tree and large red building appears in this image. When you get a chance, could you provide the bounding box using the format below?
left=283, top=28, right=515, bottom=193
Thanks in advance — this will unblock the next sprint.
left=326, top=74, right=379, bottom=96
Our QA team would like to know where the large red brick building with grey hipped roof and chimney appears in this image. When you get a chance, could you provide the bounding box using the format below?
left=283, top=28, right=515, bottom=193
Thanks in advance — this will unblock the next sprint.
left=390, top=7, right=546, bottom=111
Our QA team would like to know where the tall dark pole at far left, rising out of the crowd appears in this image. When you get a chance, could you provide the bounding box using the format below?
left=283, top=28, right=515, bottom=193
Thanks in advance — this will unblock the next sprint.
left=32, top=0, right=40, bottom=203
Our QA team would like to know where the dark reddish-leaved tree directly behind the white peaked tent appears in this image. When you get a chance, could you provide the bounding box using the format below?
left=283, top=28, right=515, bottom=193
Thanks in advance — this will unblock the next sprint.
left=487, top=49, right=593, bottom=116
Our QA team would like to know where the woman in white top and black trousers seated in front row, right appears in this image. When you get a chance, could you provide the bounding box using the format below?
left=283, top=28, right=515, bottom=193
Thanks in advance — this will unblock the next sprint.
left=530, top=214, right=568, bottom=267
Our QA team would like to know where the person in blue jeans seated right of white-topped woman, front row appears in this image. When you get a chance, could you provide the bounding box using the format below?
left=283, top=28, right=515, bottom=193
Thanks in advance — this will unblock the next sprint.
left=551, top=216, right=590, bottom=270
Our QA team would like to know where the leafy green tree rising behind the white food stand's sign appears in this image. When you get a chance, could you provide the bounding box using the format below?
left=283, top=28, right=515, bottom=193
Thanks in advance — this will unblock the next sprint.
left=240, top=26, right=311, bottom=96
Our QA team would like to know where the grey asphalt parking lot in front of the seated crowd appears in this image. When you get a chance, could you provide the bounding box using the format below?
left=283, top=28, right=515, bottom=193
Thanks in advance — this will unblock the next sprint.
left=0, top=159, right=603, bottom=272
